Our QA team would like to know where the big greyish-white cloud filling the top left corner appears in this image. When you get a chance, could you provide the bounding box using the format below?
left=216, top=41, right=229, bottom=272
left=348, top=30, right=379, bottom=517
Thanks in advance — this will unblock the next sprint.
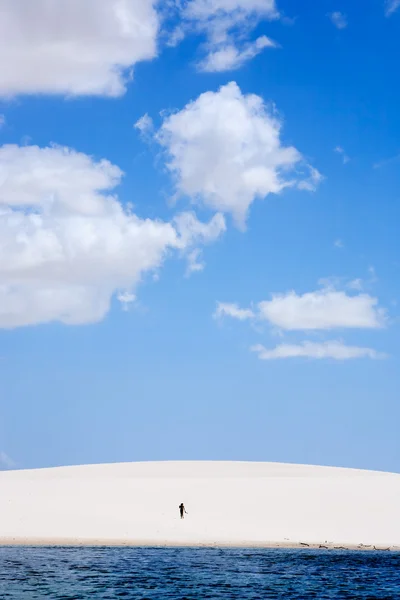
left=0, top=0, right=158, bottom=96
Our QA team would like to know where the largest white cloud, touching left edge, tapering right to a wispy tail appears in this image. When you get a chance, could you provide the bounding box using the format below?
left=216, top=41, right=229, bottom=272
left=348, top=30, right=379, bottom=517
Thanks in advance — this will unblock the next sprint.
left=0, top=145, right=225, bottom=328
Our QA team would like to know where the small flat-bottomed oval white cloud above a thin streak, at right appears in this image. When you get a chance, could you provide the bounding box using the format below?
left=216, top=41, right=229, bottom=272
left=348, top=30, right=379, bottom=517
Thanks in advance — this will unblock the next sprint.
left=258, top=288, right=385, bottom=330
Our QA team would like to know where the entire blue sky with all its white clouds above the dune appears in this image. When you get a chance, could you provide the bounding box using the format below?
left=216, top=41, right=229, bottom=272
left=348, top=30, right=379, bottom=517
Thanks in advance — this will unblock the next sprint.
left=0, top=0, right=400, bottom=472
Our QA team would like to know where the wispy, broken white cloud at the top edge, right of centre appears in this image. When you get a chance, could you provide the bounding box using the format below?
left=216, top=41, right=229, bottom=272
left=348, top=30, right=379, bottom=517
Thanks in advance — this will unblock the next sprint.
left=177, top=0, right=280, bottom=71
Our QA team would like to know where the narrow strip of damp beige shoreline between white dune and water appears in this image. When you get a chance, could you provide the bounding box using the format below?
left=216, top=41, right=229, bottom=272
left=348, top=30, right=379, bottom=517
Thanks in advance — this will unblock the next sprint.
left=0, top=538, right=400, bottom=552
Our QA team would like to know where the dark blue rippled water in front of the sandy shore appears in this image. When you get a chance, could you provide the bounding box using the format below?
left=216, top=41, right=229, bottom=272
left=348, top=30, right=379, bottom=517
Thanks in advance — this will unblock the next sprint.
left=0, top=548, right=400, bottom=600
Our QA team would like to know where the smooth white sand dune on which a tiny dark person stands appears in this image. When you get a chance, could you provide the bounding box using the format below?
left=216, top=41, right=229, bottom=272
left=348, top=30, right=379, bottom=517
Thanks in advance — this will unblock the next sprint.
left=0, top=462, right=400, bottom=549
